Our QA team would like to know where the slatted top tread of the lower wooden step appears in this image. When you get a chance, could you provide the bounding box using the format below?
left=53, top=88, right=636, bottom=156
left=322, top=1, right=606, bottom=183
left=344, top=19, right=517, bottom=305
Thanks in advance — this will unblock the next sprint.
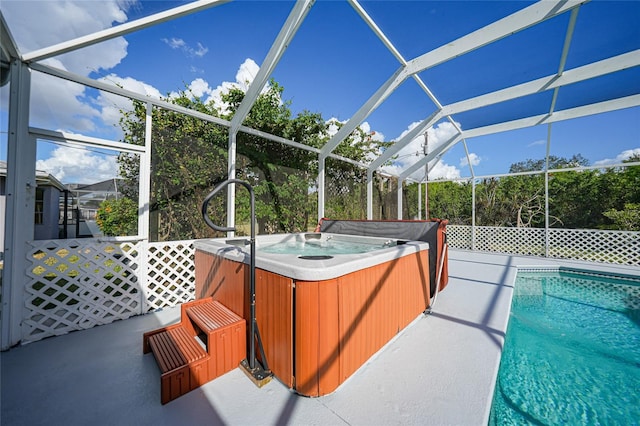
left=149, top=327, right=208, bottom=374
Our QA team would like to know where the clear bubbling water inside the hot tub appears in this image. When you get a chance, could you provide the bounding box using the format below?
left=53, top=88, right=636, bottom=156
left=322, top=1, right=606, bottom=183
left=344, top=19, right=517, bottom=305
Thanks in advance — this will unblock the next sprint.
left=258, top=239, right=396, bottom=256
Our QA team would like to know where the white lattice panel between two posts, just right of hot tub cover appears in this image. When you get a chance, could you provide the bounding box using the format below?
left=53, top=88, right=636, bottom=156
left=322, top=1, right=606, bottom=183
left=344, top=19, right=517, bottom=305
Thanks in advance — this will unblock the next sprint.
left=474, top=226, right=545, bottom=256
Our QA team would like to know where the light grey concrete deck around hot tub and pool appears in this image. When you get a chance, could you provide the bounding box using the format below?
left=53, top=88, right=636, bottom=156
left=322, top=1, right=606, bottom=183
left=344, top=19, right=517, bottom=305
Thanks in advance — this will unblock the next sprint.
left=0, top=250, right=640, bottom=426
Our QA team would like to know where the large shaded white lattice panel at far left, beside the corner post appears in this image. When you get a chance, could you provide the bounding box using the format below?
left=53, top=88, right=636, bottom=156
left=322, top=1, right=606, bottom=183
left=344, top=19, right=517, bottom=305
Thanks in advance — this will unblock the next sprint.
left=22, top=239, right=142, bottom=343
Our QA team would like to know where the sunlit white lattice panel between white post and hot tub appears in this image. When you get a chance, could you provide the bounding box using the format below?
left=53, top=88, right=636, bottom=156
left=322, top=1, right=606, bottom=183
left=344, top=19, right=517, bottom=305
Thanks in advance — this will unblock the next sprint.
left=146, top=240, right=195, bottom=311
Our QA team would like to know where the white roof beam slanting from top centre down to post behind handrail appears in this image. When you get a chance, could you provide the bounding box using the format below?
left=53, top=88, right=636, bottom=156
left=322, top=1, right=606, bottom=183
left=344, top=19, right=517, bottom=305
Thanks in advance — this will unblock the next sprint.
left=229, top=0, right=315, bottom=133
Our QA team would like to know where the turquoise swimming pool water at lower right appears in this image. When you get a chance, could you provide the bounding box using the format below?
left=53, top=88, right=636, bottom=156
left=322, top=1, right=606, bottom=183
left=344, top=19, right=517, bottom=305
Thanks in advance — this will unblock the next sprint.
left=489, top=271, right=640, bottom=425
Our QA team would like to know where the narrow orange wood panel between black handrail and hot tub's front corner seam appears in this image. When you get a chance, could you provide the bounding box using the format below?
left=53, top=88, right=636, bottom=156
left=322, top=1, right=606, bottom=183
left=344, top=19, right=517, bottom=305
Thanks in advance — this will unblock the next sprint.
left=256, top=269, right=294, bottom=388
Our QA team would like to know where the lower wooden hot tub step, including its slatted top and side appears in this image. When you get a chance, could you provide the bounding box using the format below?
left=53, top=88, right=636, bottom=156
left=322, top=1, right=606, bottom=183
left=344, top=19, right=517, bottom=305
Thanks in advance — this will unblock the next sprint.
left=147, top=326, right=212, bottom=404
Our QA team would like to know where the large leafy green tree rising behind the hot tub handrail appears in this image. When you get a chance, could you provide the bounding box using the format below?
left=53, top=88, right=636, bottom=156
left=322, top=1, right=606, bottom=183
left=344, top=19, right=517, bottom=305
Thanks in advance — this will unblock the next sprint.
left=119, top=80, right=384, bottom=240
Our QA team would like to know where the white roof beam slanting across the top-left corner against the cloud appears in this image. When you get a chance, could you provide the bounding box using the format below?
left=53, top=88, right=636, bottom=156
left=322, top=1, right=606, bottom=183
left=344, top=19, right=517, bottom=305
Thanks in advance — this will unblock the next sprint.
left=22, top=0, right=230, bottom=62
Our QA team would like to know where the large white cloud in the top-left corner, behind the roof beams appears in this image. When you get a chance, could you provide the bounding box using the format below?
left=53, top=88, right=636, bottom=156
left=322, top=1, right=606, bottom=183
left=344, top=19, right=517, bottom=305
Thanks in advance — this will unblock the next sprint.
left=2, top=0, right=136, bottom=132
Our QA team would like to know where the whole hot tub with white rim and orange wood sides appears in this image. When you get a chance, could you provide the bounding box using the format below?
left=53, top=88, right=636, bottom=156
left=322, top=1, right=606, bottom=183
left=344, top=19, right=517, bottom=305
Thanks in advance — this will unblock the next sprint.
left=194, top=233, right=430, bottom=396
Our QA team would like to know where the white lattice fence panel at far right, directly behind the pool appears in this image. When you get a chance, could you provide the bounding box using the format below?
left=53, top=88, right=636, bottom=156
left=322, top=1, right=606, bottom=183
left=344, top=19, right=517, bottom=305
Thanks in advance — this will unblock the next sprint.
left=549, top=229, right=640, bottom=265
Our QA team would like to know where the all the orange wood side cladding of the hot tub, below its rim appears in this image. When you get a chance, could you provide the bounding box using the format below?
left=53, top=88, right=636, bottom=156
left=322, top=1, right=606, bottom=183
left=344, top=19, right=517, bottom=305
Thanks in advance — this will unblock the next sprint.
left=196, top=246, right=428, bottom=396
